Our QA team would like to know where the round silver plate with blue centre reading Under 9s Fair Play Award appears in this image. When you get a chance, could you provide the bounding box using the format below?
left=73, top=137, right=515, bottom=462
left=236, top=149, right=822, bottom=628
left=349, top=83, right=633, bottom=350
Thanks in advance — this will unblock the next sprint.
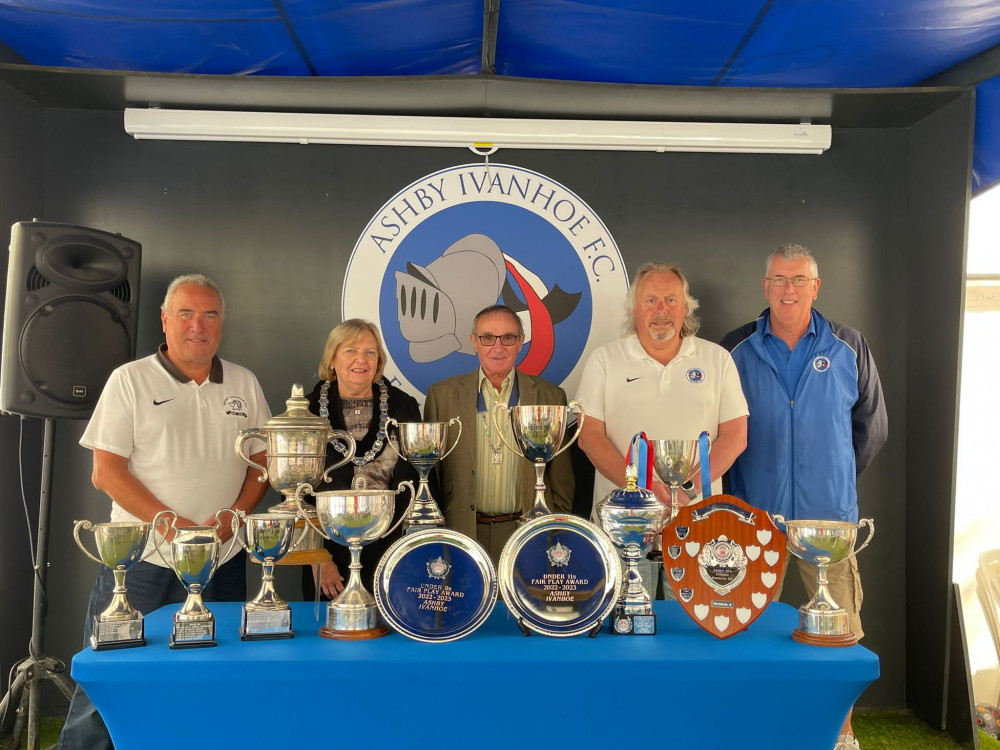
left=375, top=529, right=497, bottom=643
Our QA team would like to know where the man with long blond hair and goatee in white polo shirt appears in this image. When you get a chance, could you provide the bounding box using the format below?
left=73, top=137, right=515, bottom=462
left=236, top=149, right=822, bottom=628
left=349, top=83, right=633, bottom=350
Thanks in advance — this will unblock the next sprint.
left=577, top=263, right=749, bottom=596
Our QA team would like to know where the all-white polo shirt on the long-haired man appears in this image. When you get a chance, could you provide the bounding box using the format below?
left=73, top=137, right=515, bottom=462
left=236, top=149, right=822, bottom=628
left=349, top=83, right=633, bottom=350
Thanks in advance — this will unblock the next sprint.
left=577, top=334, right=750, bottom=504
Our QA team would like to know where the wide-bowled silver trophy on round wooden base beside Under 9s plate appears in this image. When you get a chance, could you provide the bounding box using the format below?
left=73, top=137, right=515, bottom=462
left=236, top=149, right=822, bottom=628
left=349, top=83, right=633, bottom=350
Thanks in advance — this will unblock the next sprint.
left=296, top=477, right=416, bottom=640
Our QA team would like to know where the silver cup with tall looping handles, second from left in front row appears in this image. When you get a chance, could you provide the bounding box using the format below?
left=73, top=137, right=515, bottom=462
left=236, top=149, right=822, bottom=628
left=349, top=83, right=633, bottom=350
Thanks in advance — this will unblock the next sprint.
left=153, top=508, right=240, bottom=648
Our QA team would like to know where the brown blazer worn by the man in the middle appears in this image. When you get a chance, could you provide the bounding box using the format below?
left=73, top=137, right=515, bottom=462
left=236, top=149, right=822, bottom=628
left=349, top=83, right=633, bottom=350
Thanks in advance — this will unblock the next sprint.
left=424, top=369, right=575, bottom=539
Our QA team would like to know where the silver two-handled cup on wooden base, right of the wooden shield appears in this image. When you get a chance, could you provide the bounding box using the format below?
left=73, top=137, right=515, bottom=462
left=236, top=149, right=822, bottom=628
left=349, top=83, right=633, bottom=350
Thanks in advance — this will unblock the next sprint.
left=771, top=515, right=875, bottom=646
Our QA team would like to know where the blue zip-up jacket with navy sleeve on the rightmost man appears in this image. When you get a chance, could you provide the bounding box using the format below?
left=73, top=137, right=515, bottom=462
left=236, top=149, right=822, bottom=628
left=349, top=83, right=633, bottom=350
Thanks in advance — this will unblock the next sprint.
left=722, top=310, right=889, bottom=522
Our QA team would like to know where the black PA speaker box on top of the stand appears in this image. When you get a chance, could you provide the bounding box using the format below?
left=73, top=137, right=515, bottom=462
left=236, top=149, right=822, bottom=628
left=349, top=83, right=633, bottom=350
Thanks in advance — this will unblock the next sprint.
left=0, top=221, right=142, bottom=419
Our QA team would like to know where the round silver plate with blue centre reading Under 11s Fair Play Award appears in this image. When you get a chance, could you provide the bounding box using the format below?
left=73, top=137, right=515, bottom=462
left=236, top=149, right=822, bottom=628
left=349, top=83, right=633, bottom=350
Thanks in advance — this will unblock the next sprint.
left=498, top=513, right=622, bottom=636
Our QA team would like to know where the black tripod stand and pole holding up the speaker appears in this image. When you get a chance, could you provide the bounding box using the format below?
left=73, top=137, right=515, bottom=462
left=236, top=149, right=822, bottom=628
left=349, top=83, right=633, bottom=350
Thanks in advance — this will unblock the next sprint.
left=0, top=419, right=76, bottom=750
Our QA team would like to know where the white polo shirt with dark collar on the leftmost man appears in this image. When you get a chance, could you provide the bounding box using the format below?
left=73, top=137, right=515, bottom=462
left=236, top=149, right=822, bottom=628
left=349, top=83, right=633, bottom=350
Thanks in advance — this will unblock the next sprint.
left=80, top=346, right=271, bottom=566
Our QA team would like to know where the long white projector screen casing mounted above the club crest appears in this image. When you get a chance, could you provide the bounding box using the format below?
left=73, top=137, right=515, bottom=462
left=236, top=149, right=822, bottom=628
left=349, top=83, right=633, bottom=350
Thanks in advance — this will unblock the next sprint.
left=125, top=109, right=831, bottom=154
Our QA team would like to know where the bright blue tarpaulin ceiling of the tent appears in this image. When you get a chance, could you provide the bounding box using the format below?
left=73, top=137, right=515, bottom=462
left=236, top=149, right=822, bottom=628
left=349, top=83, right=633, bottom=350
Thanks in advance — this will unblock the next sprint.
left=0, top=0, right=1000, bottom=190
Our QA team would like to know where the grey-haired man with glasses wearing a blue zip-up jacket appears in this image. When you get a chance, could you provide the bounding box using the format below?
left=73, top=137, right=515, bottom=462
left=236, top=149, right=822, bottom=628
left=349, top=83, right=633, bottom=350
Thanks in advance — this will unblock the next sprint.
left=722, top=245, right=888, bottom=750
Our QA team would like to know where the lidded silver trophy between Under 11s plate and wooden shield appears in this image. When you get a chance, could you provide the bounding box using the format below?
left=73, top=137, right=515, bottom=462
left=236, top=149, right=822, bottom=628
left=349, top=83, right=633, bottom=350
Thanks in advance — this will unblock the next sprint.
left=597, top=464, right=677, bottom=635
